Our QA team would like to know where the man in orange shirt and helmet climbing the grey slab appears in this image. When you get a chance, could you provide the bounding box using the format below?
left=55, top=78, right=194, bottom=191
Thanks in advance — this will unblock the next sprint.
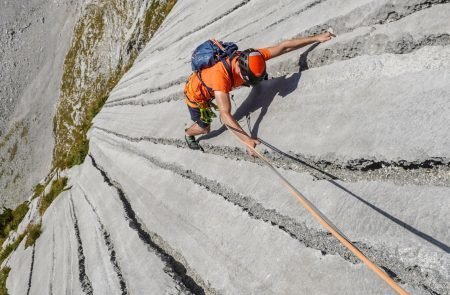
left=184, top=32, right=335, bottom=156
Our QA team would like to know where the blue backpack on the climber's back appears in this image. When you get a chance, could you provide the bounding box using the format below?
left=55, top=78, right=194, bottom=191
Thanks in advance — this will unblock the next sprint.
left=191, top=39, right=238, bottom=91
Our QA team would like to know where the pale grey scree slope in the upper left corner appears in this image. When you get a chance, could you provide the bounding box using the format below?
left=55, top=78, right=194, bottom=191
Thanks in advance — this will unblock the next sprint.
left=0, top=0, right=81, bottom=207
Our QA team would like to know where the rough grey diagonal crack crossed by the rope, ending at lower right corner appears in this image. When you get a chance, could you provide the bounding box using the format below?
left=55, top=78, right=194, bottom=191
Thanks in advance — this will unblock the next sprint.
left=90, top=135, right=447, bottom=294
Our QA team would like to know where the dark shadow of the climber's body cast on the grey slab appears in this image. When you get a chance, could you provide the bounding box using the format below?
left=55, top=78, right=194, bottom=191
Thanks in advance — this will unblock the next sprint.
left=198, top=43, right=319, bottom=141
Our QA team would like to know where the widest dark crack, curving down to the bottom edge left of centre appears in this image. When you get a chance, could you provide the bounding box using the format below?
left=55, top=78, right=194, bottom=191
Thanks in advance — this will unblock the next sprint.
left=89, top=154, right=211, bottom=294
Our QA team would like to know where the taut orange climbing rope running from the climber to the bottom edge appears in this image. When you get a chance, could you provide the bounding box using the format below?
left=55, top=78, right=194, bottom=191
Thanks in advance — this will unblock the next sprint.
left=224, top=124, right=408, bottom=295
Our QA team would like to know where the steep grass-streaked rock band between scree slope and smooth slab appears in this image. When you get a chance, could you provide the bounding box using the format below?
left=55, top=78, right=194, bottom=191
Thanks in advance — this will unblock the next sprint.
left=53, top=0, right=175, bottom=170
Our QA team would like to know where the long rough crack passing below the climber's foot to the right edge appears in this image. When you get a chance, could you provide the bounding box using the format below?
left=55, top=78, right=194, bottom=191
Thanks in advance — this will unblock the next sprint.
left=94, top=126, right=450, bottom=187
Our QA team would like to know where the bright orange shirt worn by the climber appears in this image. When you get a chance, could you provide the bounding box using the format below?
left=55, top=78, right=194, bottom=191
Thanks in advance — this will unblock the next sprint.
left=185, top=48, right=272, bottom=107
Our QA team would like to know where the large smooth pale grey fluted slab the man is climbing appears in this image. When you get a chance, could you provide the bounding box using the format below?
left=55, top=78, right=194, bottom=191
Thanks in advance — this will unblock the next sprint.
left=5, top=0, right=450, bottom=294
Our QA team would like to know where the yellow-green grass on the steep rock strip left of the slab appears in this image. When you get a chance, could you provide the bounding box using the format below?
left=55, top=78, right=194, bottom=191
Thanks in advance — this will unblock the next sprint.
left=53, top=0, right=176, bottom=170
